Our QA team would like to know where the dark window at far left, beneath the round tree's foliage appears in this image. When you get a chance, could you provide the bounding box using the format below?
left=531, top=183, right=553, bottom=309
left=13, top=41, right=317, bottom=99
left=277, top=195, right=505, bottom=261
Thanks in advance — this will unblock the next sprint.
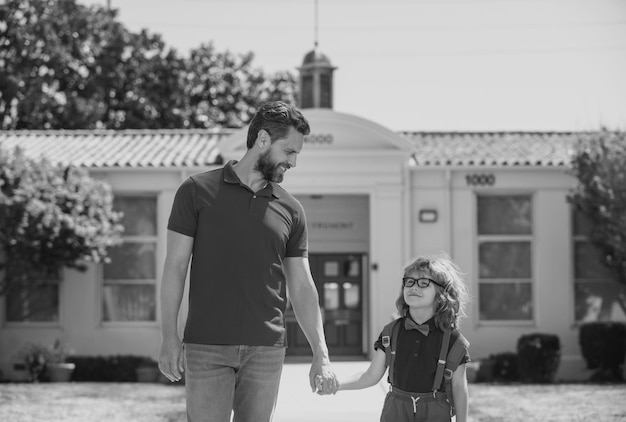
left=5, top=274, right=60, bottom=323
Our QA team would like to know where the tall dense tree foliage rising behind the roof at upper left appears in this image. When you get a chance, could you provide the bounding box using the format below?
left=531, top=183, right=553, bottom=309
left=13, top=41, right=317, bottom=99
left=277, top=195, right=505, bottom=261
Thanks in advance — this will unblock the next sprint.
left=0, top=0, right=296, bottom=129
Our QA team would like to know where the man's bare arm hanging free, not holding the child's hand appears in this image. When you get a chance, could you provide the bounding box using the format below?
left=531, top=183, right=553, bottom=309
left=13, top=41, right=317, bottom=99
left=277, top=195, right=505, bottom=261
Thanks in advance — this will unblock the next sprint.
left=159, top=230, right=193, bottom=382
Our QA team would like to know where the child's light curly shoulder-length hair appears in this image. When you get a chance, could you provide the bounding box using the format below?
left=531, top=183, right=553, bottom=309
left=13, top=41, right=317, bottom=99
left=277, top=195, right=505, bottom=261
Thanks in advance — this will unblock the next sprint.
left=396, top=253, right=469, bottom=330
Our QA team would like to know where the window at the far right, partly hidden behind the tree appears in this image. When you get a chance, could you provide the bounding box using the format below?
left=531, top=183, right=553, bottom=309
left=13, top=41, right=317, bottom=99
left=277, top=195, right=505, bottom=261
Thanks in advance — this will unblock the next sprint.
left=572, top=212, right=626, bottom=322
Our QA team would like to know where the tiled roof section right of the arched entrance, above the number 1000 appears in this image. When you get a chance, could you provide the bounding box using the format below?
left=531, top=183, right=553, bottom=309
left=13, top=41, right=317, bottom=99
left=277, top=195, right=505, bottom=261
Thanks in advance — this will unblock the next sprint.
left=400, top=132, right=592, bottom=167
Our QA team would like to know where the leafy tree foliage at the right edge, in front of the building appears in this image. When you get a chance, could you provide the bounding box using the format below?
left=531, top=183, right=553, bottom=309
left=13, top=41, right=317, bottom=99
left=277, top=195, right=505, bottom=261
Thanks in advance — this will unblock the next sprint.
left=567, top=130, right=626, bottom=285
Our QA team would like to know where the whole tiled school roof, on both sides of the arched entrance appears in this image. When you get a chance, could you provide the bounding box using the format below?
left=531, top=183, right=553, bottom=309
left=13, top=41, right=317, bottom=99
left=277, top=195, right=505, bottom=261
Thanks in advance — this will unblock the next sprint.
left=0, top=129, right=591, bottom=168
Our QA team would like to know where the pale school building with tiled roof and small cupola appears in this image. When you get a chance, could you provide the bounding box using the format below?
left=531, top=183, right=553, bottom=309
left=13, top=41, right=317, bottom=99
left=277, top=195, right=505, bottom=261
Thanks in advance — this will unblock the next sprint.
left=0, top=50, right=626, bottom=380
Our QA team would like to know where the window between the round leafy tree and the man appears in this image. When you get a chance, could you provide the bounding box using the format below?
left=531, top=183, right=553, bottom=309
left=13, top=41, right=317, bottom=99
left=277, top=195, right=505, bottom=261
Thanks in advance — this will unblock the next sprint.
left=102, top=195, right=157, bottom=322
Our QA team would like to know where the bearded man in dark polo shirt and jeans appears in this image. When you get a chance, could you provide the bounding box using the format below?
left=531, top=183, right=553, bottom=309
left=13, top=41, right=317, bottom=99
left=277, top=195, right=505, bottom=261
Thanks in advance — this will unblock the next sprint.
left=159, top=102, right=337, bottom=422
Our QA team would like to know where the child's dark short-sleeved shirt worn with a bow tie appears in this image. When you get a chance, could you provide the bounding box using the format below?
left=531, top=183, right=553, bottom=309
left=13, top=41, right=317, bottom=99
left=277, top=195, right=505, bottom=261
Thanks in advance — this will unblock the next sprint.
left=374, top=316, right=470, bottom=393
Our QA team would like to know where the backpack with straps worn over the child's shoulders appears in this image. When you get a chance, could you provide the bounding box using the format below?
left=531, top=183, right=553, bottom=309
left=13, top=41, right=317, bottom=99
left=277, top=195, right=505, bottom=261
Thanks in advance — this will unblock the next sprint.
left=382, top=318, right=469, bottom=416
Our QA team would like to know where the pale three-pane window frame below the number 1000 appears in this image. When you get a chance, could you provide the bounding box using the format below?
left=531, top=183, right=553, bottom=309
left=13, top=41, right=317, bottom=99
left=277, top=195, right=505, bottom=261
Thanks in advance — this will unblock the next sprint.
left=473, top=189, right=538, bottom=326
